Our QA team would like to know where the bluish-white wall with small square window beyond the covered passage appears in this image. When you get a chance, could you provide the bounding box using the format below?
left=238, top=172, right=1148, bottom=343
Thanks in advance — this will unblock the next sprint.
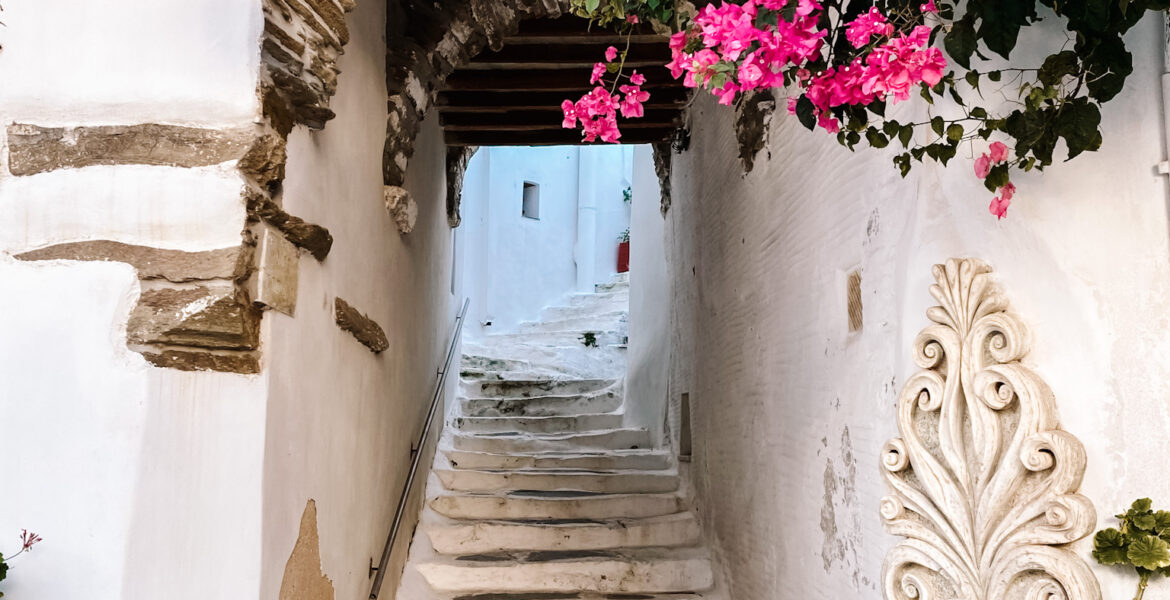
left=456, top=146, right=632, bottom=337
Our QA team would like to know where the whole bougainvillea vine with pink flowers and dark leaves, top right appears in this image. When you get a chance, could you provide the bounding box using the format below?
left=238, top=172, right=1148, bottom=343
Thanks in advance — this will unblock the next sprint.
left=562, top=0, right=1170, bottom=219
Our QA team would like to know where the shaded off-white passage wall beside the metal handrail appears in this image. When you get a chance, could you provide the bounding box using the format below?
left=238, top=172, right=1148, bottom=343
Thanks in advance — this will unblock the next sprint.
left=260, top=2, right=455, bottom=599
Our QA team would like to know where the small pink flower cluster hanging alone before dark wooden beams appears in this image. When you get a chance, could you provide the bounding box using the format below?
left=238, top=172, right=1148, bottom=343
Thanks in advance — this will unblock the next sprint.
left=560, top=46, right=651, bottom=143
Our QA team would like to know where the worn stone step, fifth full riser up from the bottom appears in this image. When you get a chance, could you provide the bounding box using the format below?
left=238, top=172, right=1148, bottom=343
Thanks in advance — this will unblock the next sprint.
left=443, top=450, right=670, bottom=470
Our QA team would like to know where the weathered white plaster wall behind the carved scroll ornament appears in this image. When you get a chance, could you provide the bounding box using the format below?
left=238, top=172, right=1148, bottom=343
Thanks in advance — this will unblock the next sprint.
left=659, top=10, right=1170, bottom=600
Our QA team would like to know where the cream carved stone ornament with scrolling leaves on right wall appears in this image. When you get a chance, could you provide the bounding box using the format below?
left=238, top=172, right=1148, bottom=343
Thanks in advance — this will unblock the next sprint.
left=881, top=258, right=1101, bottom=600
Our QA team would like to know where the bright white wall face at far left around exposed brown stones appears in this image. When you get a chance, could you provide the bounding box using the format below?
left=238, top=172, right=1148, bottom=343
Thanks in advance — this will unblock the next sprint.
left=0, top=0, right=268, bottom=599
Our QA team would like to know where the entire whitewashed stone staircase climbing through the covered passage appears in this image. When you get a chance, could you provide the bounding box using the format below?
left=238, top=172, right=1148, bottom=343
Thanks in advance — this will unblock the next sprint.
left=397, top=277, right=714, bottom=600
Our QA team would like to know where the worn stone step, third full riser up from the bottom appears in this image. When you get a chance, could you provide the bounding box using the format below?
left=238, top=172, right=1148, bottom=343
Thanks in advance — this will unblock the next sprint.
left=428, top=492, right=686, bottom=520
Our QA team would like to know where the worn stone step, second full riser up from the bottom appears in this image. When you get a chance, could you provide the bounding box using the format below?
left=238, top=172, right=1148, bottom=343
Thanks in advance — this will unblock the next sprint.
left=427, top=512, right=700, bottom=554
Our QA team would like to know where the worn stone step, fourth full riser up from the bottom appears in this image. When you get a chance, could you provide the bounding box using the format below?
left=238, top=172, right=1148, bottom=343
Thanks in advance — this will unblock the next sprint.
left=435, top=469, right=679, bottom=494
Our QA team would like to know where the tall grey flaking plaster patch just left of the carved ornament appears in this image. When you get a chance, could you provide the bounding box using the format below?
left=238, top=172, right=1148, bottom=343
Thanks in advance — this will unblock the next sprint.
left=820, top=427, right=870, bottom=591
